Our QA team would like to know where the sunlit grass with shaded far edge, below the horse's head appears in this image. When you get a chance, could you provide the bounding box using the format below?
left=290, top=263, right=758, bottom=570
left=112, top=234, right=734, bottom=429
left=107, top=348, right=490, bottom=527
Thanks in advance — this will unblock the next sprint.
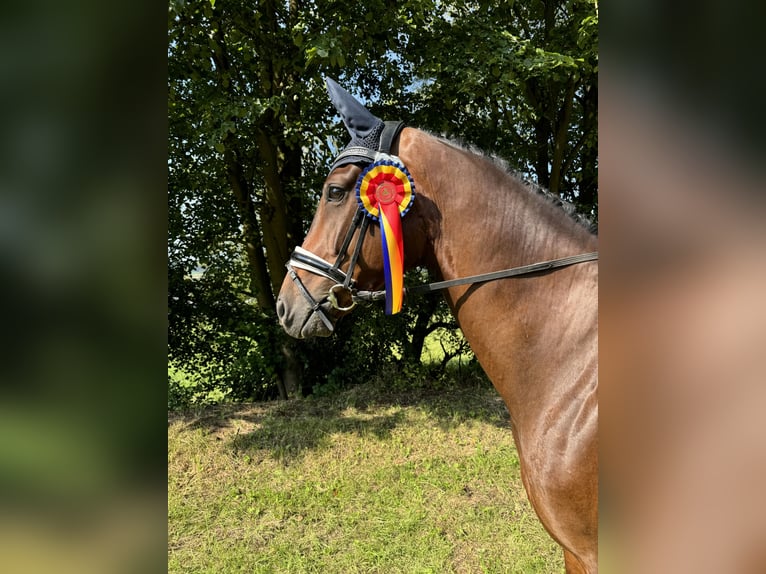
left=168, top=384, right=563, bottom=574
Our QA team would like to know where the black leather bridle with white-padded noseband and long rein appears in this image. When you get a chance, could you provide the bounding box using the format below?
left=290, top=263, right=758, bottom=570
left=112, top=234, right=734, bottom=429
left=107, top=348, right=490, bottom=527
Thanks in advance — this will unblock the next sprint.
left=286, top=122, right=598, bottom=331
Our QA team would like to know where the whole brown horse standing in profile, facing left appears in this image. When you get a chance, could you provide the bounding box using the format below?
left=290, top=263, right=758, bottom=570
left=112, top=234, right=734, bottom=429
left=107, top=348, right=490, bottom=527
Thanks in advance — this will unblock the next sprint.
left=277, top=82, right=598, bottom=573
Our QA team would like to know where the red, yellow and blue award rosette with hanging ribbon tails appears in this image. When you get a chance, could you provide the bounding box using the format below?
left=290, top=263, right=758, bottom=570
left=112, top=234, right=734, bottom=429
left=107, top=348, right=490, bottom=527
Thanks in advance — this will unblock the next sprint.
left=356, top=156, right=415, bottom=315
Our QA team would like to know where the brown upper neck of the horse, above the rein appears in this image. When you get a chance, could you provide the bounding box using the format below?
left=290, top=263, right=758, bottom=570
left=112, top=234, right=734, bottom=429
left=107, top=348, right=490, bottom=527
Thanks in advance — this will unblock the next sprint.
left=400, top=132, right=597, bottom=279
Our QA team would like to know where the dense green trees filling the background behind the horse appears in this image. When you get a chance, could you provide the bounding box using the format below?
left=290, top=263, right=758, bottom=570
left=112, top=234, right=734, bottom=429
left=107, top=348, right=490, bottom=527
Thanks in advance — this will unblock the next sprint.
left=168, top=0, right=598, bottom=404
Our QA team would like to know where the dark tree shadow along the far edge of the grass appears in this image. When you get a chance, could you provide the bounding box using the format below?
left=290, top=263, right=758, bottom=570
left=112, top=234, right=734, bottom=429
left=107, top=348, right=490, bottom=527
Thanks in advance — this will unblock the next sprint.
left=171, top=382, right=510, bottom=464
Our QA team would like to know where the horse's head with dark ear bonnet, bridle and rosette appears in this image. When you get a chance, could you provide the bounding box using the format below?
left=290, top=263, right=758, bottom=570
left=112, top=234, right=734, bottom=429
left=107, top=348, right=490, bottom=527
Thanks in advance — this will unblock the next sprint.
left=277, top=78, right=432, bottom=338
